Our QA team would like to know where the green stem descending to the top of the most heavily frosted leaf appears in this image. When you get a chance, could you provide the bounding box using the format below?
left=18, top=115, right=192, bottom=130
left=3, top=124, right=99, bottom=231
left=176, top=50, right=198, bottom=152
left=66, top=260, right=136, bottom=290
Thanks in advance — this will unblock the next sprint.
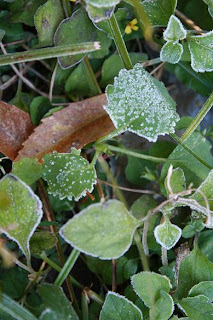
left=108, top=14, right=133, bottom=70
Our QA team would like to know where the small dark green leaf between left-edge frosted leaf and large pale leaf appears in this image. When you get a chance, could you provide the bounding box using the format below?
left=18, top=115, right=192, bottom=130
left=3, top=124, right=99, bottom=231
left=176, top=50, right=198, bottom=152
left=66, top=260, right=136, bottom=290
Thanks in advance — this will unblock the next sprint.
left=30, top=231, right=57, bottom=255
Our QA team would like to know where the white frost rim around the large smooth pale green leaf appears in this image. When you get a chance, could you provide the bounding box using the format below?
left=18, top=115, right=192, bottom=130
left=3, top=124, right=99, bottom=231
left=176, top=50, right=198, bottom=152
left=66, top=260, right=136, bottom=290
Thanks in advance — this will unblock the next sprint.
left=59, top=199, right=140, bottom=260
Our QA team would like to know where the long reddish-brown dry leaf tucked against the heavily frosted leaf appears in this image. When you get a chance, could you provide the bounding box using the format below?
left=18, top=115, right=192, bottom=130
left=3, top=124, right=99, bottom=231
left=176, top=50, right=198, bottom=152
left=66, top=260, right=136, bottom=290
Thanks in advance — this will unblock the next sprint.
left=15, top=94, right=114, bottom=161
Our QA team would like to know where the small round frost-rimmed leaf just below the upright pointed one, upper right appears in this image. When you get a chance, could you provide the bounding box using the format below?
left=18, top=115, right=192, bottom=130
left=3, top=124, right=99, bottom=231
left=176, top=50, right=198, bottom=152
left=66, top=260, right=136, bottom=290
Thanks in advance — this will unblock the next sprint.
left=160, top=41, right=183, bottom=64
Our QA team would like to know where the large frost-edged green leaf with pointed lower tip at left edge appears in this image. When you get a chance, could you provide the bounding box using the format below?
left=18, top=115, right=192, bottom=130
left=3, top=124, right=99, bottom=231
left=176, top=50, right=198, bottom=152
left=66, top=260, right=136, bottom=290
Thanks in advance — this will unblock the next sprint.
left=0, top=174, right=43, bottom=260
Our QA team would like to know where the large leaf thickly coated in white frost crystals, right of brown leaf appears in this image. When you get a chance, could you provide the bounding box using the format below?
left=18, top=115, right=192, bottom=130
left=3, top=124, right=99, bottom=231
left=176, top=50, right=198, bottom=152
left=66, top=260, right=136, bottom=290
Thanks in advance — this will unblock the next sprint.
left=104, top=64, right=179, bottom=141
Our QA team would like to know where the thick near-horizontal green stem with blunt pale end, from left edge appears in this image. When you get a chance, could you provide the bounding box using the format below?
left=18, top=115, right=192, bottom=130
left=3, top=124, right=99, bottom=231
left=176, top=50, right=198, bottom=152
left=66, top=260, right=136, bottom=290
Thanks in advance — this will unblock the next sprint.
left=0, top=42, right=100, bottom=66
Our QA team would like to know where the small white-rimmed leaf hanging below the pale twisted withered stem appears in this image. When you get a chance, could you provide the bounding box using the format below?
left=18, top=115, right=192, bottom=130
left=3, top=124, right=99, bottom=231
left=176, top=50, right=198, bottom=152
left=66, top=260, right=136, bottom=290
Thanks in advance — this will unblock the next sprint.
left=154, top=219, right=182, bottom=250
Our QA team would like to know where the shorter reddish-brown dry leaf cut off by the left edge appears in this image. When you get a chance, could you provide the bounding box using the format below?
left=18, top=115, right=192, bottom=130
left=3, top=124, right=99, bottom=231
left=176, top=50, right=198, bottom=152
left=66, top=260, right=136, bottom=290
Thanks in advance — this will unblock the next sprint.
left=0, top=101, right=34, bottom=160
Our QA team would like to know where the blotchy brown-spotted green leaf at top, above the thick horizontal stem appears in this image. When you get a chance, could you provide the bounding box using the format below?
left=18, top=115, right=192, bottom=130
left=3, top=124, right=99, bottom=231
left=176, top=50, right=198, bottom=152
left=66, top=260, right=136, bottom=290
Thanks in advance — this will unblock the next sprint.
left=34, top=0, right=64, bottom=47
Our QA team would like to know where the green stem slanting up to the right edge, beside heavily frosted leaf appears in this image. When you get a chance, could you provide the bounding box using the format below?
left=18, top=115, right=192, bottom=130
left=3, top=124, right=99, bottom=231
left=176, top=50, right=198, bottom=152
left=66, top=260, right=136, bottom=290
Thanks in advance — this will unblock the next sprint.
left=181, top=92, right=213, bottom=142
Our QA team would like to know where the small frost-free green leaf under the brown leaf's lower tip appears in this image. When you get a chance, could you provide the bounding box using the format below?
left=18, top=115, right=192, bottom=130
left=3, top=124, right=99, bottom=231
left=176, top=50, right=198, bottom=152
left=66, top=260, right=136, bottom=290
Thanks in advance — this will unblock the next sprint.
left=12, top=158, right=42, bottom=185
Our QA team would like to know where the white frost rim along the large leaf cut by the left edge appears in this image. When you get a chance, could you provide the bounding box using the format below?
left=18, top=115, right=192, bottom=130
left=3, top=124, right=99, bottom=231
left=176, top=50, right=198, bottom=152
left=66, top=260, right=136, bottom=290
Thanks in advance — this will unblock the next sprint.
left=1, top=173, right=43, bottom=258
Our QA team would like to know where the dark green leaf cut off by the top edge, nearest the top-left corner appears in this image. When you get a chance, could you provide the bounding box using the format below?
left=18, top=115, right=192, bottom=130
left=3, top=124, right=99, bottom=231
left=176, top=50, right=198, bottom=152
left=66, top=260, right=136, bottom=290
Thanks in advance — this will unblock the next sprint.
left=9, top=0, right=44, bottom=26
